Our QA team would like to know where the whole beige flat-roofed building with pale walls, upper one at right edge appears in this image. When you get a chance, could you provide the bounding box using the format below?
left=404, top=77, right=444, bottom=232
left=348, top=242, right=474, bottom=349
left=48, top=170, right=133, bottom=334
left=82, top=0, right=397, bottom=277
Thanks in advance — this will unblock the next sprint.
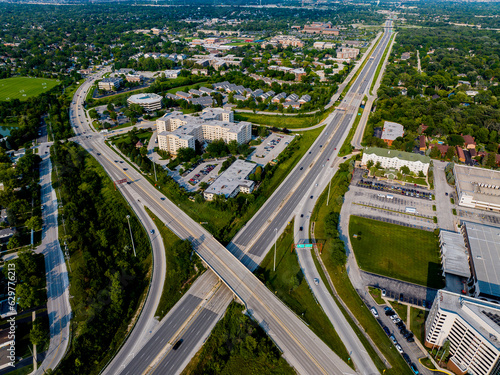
left=453, top=164, right=500, bottom=212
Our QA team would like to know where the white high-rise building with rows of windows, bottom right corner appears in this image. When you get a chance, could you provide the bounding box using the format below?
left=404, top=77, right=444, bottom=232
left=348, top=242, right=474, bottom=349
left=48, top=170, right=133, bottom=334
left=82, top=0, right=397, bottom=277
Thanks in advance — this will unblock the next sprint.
left=425, top=290, right=500, bottom=375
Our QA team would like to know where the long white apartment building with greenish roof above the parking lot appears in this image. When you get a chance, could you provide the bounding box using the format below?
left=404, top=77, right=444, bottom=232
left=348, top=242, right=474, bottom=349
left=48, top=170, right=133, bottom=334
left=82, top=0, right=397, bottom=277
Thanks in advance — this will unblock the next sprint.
left=361, top=147, right=431, bottom=175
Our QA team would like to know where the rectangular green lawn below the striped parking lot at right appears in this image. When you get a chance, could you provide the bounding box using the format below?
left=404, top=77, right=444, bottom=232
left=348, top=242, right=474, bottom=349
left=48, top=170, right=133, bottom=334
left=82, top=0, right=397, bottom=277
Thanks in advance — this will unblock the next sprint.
left=349, top=216, right=444, bottom=289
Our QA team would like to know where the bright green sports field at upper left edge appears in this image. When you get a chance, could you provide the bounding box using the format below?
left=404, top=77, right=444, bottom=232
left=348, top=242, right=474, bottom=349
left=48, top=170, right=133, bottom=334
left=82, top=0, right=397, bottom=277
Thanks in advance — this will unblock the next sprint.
left=0, top=77, right=58, bottom=101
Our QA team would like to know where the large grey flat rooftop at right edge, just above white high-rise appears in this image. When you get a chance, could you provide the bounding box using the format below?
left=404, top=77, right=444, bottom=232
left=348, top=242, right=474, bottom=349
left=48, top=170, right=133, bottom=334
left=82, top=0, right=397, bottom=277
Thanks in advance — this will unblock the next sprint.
left=462, top=221, right=500, bottom=300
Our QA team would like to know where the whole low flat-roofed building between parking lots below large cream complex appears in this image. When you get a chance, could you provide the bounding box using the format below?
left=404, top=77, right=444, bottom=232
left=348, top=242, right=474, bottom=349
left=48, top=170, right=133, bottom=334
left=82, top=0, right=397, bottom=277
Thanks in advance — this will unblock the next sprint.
left=203, top=159, right=257, bottom=201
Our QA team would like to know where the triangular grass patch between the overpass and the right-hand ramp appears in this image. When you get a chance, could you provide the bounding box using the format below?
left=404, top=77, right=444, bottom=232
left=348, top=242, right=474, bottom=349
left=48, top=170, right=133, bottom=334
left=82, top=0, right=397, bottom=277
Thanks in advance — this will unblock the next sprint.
left=255, top=221, right=352, bottom=366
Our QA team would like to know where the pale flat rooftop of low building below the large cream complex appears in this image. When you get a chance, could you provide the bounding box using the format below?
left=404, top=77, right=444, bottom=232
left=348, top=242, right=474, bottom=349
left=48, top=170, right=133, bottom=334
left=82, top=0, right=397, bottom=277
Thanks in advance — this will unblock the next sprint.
left=205, top=159, right=257, bottom=198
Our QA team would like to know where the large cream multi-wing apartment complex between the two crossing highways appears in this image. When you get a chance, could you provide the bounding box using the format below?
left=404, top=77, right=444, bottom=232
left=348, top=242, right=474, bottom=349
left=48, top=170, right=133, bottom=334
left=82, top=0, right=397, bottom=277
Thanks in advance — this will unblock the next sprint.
left=156, top=108, right=252, bottom=155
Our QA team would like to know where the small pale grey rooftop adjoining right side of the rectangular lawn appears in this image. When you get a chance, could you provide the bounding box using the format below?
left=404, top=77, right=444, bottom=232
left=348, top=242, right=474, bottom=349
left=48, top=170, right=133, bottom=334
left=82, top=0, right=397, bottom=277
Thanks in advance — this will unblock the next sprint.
left=439, top=229, right=470, bottom=279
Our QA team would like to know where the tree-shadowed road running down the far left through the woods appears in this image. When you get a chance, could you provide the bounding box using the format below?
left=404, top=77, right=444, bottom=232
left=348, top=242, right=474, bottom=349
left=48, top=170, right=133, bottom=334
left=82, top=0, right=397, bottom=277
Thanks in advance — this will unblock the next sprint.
left=35, top=143, right=71, bottom=374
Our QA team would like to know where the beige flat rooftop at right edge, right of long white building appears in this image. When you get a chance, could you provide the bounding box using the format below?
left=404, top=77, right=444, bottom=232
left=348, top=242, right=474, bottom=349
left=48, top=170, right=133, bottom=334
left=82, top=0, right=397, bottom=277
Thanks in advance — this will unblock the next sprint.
left=454, top=164, right=500, bottom=204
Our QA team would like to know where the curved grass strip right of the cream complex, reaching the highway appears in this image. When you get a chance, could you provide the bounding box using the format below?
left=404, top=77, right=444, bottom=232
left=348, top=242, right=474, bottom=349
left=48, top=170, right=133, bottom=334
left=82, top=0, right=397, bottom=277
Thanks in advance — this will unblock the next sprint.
left=234, top=111, right=330, bottom=129
